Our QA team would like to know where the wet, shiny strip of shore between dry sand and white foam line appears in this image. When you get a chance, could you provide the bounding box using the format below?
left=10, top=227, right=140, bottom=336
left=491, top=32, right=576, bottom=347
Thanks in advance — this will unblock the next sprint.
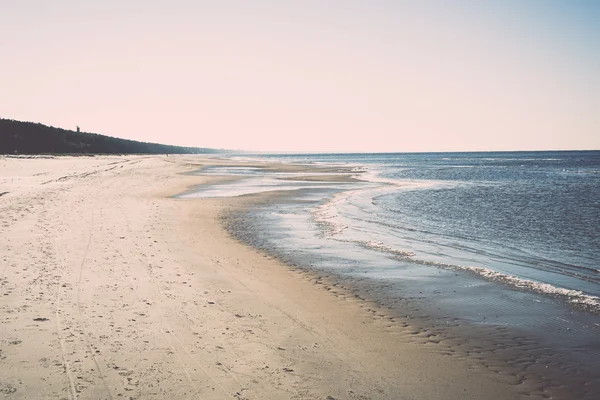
left=190, top=155, right=599, bottom=399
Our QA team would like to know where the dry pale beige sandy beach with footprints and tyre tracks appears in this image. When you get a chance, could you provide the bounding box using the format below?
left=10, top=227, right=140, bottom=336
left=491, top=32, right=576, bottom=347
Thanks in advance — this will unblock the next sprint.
left=0, top=156, right=536, bottom=399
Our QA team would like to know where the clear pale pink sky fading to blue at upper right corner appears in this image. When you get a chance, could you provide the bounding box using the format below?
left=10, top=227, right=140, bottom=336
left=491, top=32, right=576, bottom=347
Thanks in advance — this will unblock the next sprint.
left=0, top=0, right=600, bottom=152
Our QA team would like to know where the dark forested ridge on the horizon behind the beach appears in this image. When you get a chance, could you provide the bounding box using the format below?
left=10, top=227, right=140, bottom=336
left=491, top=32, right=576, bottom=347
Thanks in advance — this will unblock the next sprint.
left=0, top=118, right=219, bottom=154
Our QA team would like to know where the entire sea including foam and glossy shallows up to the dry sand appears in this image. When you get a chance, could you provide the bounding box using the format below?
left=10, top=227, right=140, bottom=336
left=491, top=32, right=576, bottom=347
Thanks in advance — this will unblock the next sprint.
left=182, top=151, right=600, bottom=398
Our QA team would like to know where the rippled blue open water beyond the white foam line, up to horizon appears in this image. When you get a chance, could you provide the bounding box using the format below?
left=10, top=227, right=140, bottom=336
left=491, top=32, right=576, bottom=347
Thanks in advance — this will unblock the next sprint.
left=250, top=151, right=600, bottom=306
